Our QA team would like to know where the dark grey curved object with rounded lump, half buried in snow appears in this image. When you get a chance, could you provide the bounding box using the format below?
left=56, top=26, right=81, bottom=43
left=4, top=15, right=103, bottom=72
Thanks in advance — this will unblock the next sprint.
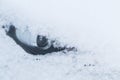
left=3, top=25, right=75, bottom=55
